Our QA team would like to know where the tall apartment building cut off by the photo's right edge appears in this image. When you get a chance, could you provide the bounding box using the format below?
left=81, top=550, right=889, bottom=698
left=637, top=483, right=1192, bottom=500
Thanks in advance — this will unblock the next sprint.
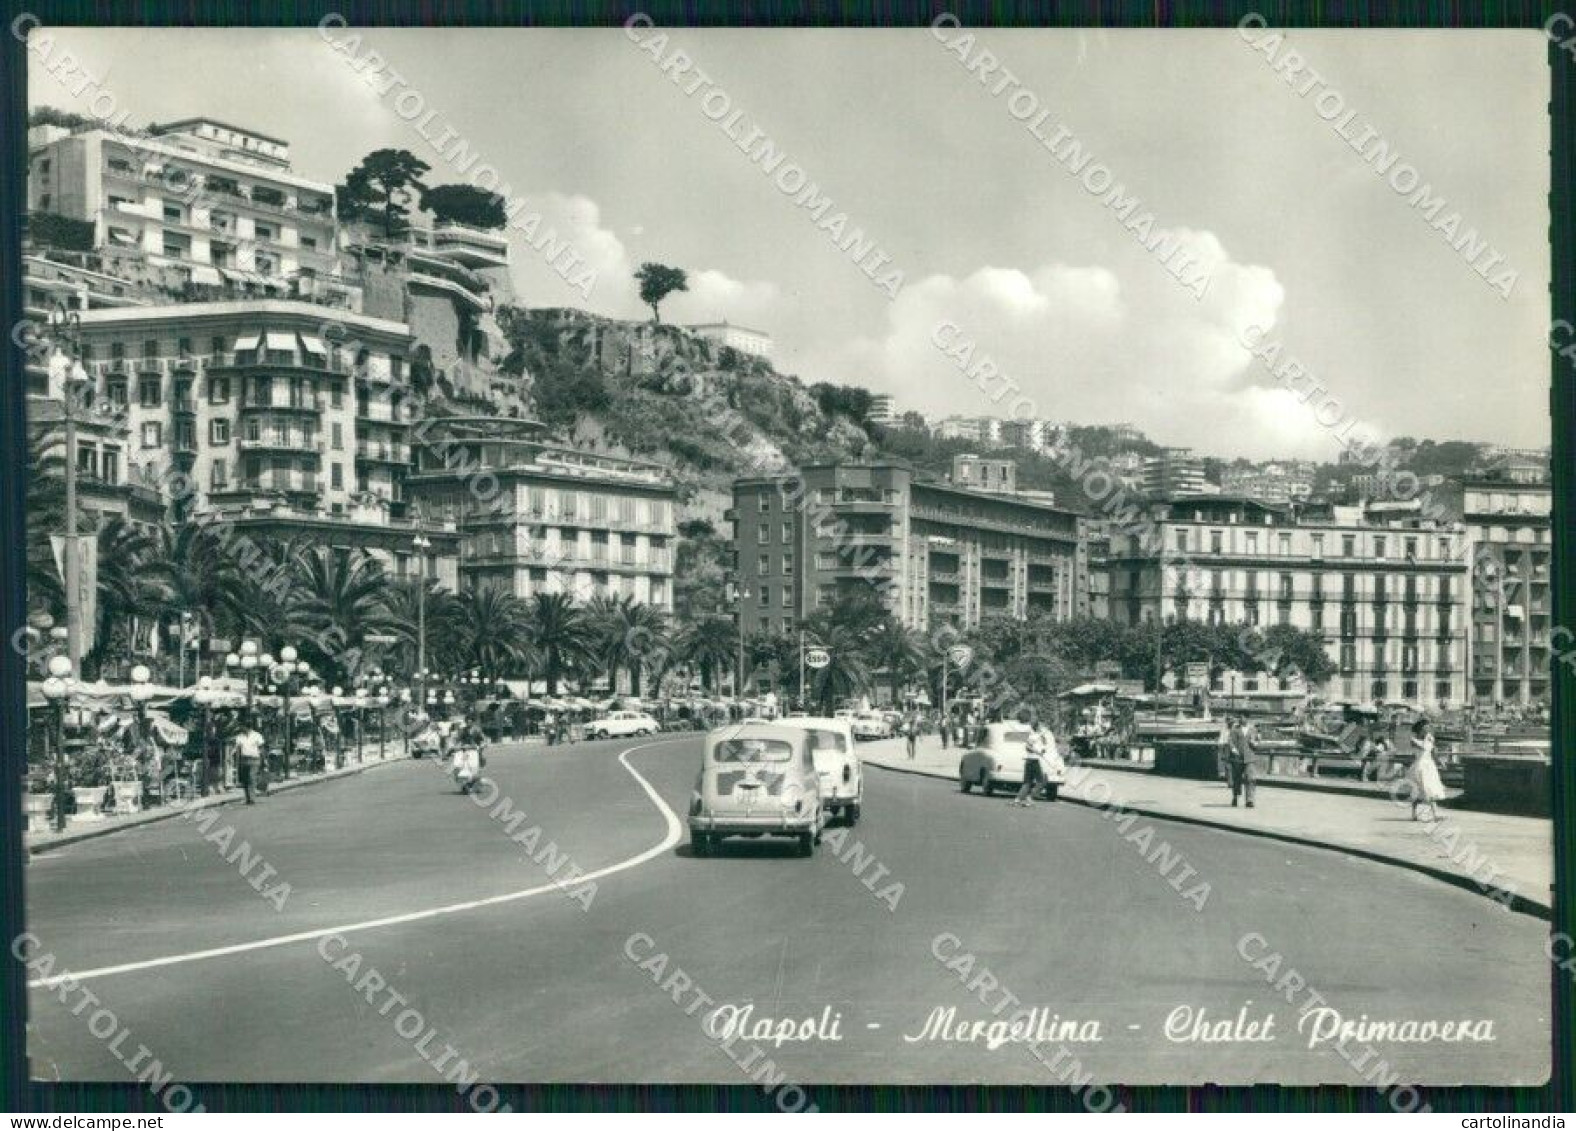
left=1463, top=473, right=1554, bottom=704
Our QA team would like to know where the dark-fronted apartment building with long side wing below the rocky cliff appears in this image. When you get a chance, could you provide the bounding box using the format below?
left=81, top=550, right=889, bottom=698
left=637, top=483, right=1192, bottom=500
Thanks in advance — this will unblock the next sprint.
left=731, top=463, right=1089, bottom=633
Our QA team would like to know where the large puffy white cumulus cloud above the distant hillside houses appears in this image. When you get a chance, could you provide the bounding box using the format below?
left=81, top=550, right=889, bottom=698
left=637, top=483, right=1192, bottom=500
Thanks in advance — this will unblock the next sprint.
left=815, top=230, right=1367, bottom=458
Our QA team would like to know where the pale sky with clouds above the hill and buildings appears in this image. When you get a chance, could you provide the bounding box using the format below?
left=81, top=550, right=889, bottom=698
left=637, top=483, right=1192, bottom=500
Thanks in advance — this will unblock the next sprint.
left=30, top=28, right=1549, bottom=460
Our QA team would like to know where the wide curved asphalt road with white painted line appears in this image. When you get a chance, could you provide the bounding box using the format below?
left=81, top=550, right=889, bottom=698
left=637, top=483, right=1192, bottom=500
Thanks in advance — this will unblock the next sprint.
left=28, top=737, right=1551, bottom=1084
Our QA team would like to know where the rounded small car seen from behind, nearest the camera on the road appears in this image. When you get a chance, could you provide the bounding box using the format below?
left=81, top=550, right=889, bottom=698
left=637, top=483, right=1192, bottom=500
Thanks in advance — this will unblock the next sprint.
left=689, top=723, right=821, bottom=855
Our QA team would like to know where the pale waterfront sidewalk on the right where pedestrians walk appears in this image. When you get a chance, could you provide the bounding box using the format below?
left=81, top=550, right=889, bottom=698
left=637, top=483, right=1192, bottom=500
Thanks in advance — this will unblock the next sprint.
left=859, top=736, right=1554, bottom=918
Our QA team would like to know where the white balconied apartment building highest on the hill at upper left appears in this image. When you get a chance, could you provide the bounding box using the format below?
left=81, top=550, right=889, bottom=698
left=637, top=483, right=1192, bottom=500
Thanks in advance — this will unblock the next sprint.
left=27, top=118, right=336, bottom=293
